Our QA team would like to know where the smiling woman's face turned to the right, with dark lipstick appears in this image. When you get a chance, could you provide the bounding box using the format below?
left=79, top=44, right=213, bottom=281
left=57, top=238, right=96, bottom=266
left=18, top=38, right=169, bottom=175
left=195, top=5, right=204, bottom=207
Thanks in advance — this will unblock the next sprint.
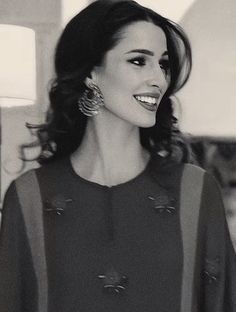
left=92, top=21, right=170, bottom=127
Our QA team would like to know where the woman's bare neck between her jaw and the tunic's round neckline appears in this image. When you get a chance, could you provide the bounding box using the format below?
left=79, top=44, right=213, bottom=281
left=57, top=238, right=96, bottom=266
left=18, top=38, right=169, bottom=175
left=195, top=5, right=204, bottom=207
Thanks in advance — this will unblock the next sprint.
left=71, top=118, right=150, bottom=186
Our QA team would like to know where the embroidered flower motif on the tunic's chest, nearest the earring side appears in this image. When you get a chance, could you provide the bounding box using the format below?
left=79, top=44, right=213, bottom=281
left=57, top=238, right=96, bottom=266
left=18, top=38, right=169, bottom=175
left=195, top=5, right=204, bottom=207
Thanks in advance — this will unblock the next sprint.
left=44, top=194, right=73, bottom=216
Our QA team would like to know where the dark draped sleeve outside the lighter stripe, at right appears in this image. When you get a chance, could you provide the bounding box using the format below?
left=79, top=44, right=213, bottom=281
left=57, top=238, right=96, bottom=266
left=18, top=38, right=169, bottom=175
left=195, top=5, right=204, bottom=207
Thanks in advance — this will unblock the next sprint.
left=198, top=173, right=236, bottom=312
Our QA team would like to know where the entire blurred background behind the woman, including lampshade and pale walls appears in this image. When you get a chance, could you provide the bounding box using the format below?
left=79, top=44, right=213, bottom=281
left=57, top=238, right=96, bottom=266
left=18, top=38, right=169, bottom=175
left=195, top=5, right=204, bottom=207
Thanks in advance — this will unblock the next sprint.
left=0, top=0, right=236, bottom=248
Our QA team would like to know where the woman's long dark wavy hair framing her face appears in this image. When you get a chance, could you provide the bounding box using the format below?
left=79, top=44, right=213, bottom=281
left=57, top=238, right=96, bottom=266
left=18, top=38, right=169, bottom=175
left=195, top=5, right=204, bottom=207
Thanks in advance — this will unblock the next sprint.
left=29, top=0, right=191, bottom=163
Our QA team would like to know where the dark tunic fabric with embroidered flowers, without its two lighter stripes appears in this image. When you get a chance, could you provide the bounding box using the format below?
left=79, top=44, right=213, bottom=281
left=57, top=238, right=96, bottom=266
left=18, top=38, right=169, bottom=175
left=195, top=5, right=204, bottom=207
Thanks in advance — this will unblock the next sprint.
left=0, top=159, right=236, bottom=312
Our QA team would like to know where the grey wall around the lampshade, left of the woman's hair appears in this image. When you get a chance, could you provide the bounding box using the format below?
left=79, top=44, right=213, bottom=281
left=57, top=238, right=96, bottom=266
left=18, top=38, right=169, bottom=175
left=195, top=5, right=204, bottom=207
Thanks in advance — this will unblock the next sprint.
left=0, top=0, right=61, bottom=197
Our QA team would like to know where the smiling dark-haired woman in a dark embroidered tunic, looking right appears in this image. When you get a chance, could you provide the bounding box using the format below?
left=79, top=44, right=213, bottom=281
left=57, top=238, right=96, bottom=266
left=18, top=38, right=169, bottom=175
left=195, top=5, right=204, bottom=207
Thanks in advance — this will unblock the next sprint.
left=0, top=0, right=236, bottom=312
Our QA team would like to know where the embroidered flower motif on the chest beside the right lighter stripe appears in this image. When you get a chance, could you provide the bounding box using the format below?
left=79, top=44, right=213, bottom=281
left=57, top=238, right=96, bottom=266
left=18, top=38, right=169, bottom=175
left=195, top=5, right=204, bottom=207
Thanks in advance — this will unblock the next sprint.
left=148, top=194, right=176, bottom=214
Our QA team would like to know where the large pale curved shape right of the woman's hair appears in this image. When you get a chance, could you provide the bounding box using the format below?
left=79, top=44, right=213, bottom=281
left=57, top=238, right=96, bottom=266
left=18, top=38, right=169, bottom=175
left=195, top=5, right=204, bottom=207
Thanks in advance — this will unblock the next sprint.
left=179, top=0, right=236, bottom=138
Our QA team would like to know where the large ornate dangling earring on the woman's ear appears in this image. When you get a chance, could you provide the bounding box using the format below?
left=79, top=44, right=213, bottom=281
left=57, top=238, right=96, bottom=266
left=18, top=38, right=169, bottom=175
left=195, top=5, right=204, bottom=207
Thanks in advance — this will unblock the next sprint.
left=78, top=82, right=104, bottom=117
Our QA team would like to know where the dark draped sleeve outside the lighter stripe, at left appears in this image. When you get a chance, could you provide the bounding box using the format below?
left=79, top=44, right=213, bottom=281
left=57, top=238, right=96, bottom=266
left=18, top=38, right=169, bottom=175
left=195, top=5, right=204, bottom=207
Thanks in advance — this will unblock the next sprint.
left=0, top=182, right=36, bottom=312
